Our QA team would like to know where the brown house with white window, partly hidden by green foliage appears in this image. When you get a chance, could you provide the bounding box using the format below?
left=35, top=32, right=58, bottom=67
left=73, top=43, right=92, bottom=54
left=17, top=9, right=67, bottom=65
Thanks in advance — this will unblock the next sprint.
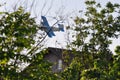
left=44, top=47, right=74, bottom=72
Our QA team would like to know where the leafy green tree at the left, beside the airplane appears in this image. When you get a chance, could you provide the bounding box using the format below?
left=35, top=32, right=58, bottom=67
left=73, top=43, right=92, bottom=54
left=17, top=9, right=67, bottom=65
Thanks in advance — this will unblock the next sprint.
left=0, top=7, right=38, bottom=80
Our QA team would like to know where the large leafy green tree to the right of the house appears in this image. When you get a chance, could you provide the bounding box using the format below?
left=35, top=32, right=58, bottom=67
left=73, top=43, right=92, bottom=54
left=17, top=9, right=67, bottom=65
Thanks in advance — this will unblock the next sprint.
left=62, top=0, right=120, bottom=80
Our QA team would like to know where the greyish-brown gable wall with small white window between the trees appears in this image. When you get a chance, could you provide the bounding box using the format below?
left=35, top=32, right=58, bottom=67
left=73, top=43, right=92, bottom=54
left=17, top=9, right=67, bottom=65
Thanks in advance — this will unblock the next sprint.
left=44, top=48, right=70, bottom=72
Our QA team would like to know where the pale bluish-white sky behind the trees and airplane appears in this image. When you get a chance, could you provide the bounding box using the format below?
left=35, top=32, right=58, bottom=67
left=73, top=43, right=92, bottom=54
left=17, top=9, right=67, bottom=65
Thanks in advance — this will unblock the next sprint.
left=0, top=0, right=120, bottom=51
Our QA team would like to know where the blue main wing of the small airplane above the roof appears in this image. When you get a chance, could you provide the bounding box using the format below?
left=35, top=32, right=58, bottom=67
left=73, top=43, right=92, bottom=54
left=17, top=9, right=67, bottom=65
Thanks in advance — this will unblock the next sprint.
left=41, top=16, right=55, bottom=37
